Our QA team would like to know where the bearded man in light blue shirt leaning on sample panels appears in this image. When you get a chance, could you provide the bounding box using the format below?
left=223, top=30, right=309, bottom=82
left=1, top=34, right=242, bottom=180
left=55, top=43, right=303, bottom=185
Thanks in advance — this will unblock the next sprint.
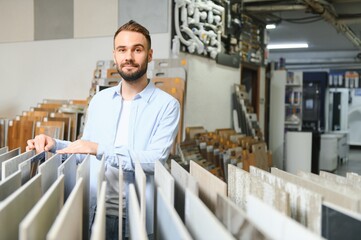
left=27, top=21, right=180, bottom=239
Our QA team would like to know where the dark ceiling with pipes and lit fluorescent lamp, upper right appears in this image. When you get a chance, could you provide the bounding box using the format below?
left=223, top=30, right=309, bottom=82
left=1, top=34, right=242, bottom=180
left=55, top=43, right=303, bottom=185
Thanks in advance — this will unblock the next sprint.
left=239, top=0, right=361, bottom=52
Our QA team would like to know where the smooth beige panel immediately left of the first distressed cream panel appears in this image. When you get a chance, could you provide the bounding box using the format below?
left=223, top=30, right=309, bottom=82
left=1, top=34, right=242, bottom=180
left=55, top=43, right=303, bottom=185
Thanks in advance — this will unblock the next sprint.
left=189, top=161, right=227, bottom=212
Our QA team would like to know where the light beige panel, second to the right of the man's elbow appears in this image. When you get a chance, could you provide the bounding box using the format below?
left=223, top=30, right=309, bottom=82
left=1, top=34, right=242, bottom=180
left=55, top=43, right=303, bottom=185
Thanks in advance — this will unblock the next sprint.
left=170, top=159, right=198, bottom=222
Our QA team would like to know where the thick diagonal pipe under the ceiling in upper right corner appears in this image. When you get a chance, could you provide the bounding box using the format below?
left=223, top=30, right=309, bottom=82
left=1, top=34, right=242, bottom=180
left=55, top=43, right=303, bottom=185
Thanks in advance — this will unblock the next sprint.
left=303, top=0, right=361, bottom=49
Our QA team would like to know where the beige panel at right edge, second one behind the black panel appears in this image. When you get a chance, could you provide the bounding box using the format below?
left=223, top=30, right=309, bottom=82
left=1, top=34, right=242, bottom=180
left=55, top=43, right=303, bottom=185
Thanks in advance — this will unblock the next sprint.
left=298, top=171, right=361, bottom=213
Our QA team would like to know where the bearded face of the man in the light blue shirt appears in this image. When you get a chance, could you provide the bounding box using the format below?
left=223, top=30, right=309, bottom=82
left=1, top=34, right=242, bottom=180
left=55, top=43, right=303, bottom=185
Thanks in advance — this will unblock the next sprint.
left=113, top=31, right=153, bottom=82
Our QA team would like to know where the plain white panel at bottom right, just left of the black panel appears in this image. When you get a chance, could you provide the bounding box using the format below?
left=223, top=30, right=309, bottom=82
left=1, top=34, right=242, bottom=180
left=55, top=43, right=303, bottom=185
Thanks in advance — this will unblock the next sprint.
left=247, top=195, right=322, bottom=240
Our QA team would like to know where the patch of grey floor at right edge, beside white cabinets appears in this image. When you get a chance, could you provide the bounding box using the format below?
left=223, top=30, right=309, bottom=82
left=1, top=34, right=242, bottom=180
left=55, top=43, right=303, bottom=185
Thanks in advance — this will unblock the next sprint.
left=335, top=148, right=361, bottom=176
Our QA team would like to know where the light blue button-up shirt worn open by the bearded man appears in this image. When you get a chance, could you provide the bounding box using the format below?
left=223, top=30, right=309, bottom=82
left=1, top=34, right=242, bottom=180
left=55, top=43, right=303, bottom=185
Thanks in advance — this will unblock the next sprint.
left=54, top=81, right=180, bottom=233
